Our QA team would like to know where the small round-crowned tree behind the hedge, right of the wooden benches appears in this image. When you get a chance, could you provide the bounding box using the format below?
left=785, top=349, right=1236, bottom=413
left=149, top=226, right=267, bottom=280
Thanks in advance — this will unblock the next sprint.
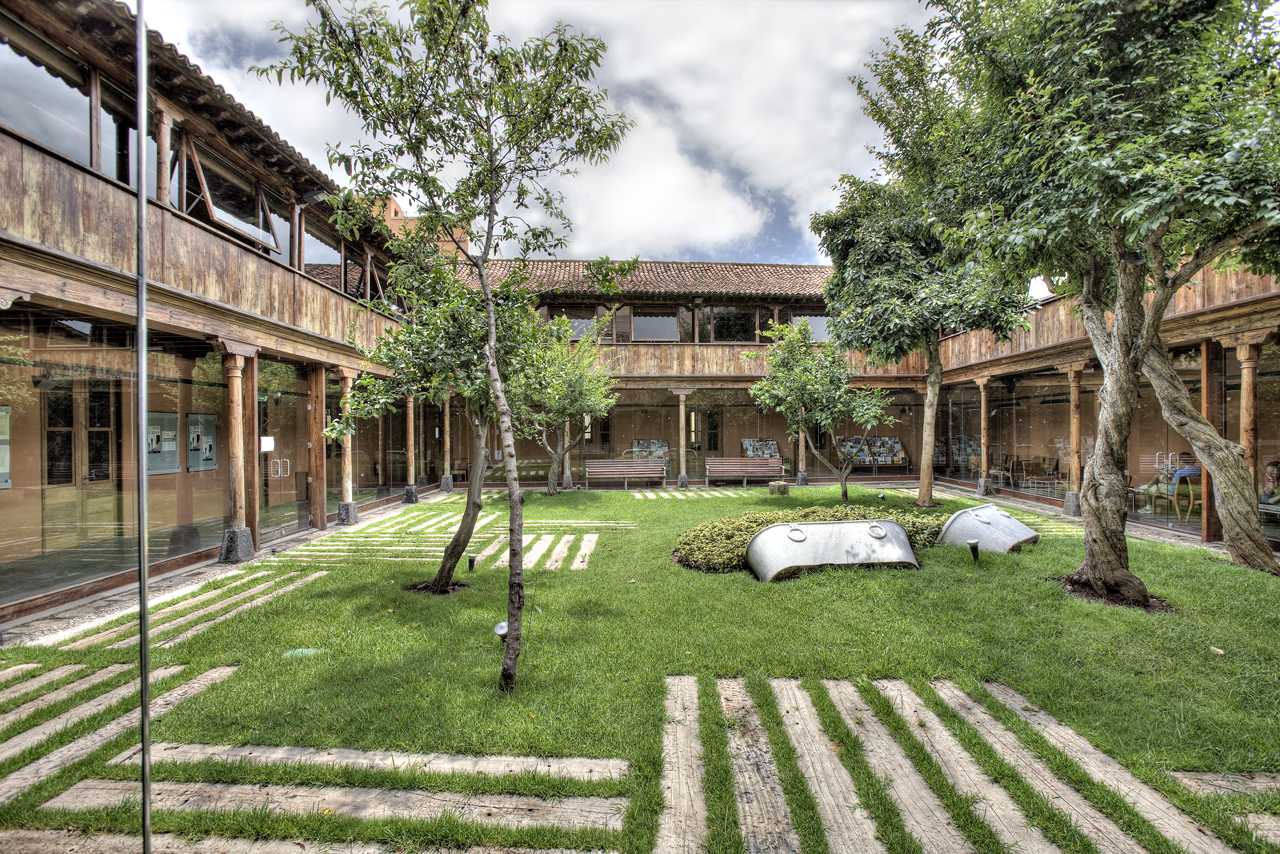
left=744, top=320, right=893, bottom=501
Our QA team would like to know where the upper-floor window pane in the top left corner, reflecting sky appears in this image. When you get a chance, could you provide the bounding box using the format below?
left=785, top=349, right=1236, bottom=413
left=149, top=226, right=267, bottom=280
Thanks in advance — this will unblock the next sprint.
left=0, top=15, right=91, bottom=165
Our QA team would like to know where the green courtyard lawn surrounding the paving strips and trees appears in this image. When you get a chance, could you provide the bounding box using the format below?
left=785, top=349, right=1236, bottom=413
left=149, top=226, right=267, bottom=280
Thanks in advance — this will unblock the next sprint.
left=0, top=487, right=1280, bottom=854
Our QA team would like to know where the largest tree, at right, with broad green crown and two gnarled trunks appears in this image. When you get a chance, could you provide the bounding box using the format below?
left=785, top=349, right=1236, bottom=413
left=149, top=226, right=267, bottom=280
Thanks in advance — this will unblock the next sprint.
left=901, top=0, right=1280, bottom=604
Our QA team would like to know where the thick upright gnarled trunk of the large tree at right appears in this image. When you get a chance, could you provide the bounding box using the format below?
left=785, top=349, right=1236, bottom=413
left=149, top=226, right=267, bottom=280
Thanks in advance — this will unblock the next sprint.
left=1076, top=250, right=1148, bottom=607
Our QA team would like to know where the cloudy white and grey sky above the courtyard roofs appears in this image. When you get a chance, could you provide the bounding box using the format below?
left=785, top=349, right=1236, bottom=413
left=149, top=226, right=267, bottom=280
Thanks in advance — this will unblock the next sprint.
left=135, top=0, right=925, bottom=264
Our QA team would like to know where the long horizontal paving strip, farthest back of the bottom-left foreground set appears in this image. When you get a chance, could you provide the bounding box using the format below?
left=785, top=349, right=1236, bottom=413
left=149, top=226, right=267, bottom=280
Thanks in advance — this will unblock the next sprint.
left=109, top=741, right=631, bottom=782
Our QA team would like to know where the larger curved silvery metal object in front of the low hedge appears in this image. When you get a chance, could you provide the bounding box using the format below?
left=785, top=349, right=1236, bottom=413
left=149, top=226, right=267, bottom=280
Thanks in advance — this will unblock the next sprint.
left=746, top=519, right=920, bottom=581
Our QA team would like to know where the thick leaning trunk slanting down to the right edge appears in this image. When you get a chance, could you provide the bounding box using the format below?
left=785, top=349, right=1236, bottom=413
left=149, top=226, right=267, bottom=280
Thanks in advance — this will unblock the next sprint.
left=1143, top=342, right=1280, bottom=575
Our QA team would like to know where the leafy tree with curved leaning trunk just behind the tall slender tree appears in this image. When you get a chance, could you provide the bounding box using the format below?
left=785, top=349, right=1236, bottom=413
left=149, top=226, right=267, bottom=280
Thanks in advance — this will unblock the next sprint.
left=325, top=260, right=548, bottom=594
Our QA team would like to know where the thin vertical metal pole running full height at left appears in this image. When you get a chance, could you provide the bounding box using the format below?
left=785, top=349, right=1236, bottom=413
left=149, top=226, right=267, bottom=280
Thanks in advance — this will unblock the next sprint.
left=133, top=0, right=160, bottom=854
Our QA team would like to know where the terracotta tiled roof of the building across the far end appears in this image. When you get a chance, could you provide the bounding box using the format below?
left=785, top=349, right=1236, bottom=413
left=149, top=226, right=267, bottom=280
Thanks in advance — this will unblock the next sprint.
left=478, top=260, right=832, bottom=301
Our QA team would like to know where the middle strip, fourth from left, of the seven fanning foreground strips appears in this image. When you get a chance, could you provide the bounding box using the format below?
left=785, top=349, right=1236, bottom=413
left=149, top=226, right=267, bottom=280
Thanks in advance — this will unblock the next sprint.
left=823, top=679, right=974, bottom=854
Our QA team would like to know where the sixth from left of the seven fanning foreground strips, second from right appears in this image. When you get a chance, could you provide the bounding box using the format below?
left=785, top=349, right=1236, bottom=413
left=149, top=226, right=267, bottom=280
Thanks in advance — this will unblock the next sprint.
left=932, top=681, right=1144, bottom=854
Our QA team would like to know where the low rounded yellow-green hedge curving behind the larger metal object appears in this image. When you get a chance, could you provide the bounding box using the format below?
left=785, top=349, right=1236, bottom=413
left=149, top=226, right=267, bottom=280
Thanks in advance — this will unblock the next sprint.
left=675, top=504, right=947, bottom=572
